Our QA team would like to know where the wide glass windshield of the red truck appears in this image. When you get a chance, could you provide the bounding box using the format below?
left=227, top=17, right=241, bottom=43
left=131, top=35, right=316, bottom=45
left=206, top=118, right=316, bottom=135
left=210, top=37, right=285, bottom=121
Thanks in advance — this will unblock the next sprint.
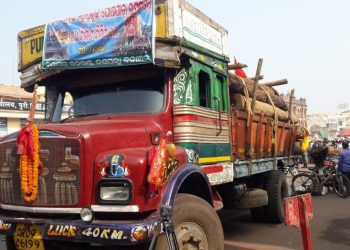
left=48, top=78, right=165, bottom=122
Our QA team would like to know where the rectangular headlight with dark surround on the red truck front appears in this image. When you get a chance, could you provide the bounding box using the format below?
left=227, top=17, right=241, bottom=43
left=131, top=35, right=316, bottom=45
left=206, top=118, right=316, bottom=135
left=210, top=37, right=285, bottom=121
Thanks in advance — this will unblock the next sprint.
left=97, top=179, right=133, bottom=204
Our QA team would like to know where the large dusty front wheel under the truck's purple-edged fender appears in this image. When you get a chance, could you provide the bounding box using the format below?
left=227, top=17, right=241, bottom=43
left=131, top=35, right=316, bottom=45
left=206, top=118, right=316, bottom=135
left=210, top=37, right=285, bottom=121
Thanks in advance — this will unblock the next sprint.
left=156, top=194, right=224, bottom=250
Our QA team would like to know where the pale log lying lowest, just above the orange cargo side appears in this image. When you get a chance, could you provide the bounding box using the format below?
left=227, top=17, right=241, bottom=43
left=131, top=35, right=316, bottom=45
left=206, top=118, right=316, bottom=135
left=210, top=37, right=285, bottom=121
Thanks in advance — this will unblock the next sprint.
left=232, top=94, right=298, bottom=123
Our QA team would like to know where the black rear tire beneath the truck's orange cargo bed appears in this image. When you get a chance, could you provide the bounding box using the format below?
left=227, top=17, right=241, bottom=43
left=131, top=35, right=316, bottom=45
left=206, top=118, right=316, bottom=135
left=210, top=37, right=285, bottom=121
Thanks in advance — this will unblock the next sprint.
left=263, top=170, right=288, bottom=223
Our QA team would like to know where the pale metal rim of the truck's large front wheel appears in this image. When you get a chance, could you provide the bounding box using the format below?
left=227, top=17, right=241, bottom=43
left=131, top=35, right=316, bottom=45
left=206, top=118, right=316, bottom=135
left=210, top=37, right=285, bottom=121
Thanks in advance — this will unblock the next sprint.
left=175, top=221, right=209, bottom=250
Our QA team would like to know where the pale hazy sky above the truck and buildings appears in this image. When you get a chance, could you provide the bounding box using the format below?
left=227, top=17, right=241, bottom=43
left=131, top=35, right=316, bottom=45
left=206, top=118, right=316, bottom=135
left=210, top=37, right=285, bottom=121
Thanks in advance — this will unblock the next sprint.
left=0, top=0, right=350, bottom=114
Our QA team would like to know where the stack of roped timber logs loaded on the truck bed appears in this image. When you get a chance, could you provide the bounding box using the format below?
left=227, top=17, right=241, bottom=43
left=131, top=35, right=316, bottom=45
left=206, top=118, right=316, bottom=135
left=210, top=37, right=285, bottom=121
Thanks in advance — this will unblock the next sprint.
left=228, top=74, right=298, bottom=123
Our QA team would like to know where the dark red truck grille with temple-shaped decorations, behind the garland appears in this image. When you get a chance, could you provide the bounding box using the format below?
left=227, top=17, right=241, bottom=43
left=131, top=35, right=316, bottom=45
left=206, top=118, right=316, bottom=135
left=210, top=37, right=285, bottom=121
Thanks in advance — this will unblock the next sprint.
left=0, top=137, right=80, bottom=206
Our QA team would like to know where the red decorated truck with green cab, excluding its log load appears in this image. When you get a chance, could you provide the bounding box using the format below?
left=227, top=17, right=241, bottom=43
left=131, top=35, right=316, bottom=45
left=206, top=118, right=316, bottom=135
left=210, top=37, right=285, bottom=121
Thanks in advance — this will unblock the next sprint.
left=0, top=0, right=297, bottom=250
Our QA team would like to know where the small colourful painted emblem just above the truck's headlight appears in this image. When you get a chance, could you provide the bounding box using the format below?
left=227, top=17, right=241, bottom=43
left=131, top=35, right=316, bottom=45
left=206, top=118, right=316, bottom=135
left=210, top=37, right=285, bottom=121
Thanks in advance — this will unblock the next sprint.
left=98, top=155, right=130, bottom=177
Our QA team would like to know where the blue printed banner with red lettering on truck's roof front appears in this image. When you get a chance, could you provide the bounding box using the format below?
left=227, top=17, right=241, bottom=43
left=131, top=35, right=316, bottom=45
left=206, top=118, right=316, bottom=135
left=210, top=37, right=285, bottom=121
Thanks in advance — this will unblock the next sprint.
left=42, top=0, right=154, bottom=69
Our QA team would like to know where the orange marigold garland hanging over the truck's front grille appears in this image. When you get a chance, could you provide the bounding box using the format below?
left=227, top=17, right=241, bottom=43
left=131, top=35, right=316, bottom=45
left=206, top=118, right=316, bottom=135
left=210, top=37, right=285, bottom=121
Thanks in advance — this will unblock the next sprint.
left=20, top=125, right=39, bottom=202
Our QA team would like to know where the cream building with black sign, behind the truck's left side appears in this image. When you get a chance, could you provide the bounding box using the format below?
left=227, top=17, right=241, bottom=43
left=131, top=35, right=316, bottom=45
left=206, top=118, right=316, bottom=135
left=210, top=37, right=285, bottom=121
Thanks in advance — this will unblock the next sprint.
left=0, top=84, right=45, bottom=136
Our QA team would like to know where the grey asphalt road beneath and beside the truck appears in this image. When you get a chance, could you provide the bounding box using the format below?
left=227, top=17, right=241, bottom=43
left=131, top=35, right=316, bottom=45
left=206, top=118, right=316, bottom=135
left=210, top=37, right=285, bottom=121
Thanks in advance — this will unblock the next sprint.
left=0, top=190, right=350, bottom=250
